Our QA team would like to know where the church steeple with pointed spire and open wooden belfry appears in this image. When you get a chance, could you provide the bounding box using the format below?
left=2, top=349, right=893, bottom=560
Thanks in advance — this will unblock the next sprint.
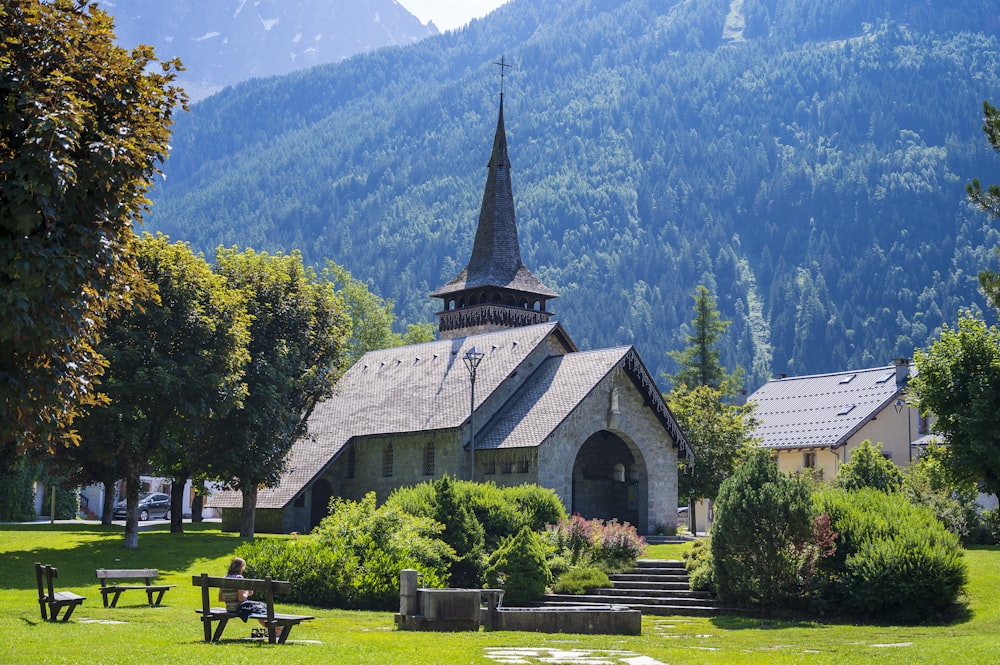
left=431, top=93, right=559, bottom=339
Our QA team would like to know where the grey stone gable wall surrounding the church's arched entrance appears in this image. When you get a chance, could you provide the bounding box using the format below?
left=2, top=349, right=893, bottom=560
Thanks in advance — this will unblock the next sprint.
left=538, top=368, right=677, bottom=533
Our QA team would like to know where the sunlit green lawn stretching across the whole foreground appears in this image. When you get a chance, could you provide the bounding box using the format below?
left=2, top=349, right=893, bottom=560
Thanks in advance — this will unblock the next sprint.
left=0, top=524, right=1000, bottom=665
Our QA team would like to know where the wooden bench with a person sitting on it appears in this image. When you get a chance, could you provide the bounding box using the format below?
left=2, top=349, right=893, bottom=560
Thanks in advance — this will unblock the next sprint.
left=191, top=573, right=315, bottom=644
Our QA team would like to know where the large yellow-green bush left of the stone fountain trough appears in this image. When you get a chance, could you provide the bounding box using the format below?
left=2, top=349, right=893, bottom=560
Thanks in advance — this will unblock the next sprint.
left=236, top=493, right=454, bottom=610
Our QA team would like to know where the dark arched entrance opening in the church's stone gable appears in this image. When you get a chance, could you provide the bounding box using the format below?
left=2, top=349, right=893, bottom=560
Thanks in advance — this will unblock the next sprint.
left=571, top=430, right=647, bottom=533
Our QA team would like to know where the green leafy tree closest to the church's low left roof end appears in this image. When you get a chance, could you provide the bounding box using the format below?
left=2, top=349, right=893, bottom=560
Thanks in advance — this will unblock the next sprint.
left=212, top=247, right=350, bottom=538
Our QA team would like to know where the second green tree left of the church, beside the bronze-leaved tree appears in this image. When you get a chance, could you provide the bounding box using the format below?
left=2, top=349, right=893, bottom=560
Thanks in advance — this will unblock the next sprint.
left=80, top=234, right=249, bottom=549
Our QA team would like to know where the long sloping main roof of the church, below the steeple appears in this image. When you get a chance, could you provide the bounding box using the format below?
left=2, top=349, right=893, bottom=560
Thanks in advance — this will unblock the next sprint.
left=210, top=323, right=576, bottom=508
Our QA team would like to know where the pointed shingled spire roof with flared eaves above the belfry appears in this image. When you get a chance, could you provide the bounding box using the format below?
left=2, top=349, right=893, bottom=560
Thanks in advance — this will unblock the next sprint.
left=431, top=96, right=559, bottom=298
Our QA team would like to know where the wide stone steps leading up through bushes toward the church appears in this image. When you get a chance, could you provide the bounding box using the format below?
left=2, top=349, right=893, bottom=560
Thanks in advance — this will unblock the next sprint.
left=540, top=559, right=719, bottom=616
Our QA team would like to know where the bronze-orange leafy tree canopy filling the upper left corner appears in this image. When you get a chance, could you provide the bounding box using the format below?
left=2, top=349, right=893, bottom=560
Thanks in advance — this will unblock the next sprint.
left=0, top=0, right=185, bottom=459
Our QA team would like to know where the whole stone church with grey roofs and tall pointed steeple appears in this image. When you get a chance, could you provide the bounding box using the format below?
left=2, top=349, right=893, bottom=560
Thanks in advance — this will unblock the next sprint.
left=208, top=93, right=690, bottom=533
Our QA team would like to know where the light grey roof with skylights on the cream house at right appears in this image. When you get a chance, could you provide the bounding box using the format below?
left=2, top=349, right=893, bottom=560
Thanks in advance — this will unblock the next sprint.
left=749, top=365, right=913, bottom=448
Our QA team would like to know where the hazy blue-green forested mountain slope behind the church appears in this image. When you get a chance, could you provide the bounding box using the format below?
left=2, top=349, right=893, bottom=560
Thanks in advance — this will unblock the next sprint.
left=150, top=0, right=1000, bottom=389
